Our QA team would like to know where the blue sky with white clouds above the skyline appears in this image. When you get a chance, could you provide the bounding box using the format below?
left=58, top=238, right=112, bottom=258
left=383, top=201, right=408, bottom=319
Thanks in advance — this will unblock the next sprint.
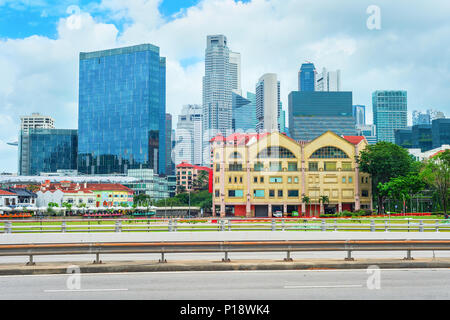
left=0, top=0, right=450, bottom=173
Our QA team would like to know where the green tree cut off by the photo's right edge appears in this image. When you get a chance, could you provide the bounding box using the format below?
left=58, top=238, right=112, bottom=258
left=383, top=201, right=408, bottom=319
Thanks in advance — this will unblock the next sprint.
left=420, top=150, right=450, bottom=219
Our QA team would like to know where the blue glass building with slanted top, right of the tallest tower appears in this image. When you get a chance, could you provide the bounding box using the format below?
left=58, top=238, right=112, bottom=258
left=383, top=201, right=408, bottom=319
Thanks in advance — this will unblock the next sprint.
left=233, top=92, right=256, bottom=132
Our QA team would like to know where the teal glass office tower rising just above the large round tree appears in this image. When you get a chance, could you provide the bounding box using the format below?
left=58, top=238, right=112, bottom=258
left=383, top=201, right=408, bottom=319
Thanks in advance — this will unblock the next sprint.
left=372, top=90, right=408, bottom=143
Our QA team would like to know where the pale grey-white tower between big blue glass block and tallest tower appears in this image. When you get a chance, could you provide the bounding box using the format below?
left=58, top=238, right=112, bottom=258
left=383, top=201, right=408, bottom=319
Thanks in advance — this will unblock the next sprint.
left=174, top=104, right=203, bottom=165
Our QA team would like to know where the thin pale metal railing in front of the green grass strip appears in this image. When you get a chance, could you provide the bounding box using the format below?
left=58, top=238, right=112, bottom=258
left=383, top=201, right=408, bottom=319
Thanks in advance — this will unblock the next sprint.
left=0, top=218, right=450, bottom=233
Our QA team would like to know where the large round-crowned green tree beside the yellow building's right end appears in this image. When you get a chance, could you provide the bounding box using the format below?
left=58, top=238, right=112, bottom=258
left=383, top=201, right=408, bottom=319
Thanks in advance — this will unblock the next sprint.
left=356, top=141, right=414, bottom=214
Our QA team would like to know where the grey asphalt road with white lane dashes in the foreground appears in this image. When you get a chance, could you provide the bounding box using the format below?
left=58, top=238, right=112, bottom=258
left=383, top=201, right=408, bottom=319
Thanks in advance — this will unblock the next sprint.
left=0, top=269, right=450, bottom=300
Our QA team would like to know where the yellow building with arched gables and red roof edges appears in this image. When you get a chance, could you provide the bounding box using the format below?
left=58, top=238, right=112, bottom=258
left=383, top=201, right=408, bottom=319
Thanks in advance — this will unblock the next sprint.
left=211, top=131, right=372, bottom=217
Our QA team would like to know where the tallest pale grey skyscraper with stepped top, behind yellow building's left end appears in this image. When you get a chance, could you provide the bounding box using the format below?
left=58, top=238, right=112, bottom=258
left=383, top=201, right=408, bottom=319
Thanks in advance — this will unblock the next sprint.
left=203, top=35, right=233, bottom=165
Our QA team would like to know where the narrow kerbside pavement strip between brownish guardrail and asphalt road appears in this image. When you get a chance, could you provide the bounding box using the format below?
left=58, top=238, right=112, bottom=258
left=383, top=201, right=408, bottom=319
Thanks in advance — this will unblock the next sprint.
left=0, top=258, right=450, bottom=275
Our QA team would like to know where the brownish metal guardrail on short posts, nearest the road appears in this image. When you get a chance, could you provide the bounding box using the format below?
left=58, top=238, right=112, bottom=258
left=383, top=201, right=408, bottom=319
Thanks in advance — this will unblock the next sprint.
left=0, top=240, right=450, bottom=265
